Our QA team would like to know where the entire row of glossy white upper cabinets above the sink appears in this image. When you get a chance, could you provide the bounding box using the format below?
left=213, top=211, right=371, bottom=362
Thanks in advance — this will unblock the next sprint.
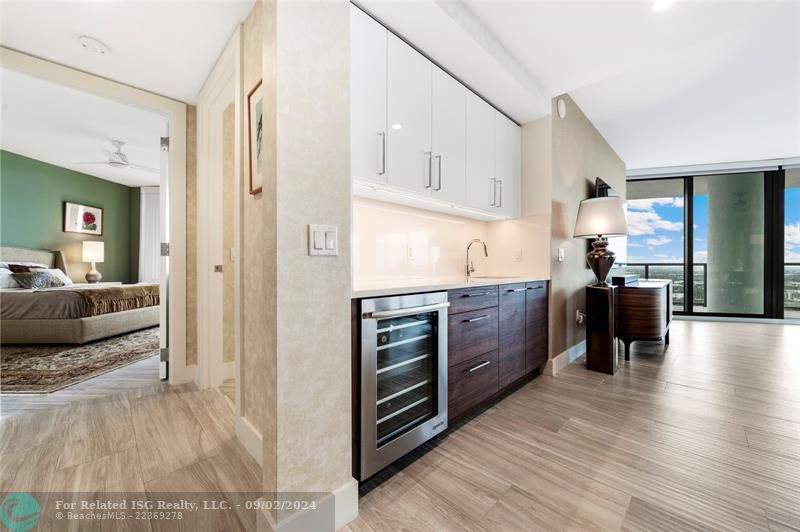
left=350, top=5, right=521, bottom=220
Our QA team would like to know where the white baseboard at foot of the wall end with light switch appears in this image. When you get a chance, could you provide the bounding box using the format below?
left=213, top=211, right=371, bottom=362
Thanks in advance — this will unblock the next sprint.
left=256, top=478, right=358, bottom=532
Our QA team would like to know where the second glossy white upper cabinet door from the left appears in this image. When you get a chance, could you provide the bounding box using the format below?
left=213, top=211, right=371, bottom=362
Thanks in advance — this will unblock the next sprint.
left=388, top=34, right=433, bottom=193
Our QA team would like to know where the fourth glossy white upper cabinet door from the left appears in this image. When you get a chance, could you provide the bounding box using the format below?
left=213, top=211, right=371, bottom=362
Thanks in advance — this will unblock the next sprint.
left=465, top=91, right=495, bottom=211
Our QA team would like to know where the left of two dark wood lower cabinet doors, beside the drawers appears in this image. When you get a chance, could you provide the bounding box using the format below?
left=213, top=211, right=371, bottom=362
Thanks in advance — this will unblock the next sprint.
left=498, top=283, right=526, bottom=388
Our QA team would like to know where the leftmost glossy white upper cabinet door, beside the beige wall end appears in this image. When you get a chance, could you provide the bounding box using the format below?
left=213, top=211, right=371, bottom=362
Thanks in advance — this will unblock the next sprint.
left=350, top=4, right=388, bottom=183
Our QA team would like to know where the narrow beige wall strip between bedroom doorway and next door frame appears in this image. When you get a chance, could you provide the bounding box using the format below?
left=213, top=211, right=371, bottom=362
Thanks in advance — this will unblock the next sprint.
left=186, top=105, right=197, bottom=366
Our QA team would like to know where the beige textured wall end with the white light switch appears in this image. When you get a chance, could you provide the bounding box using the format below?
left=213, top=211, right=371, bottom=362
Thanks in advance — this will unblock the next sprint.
left=264, top=0, right=352, bottom=491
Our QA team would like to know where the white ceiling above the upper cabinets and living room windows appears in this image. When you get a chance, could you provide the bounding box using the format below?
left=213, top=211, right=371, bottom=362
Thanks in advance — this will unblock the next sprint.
left=362, top=0, right=800, bottom=168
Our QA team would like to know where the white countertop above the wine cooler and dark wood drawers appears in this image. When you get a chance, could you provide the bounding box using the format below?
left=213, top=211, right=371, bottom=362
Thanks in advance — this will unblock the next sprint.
left=350, top=277, right=549, bottom=299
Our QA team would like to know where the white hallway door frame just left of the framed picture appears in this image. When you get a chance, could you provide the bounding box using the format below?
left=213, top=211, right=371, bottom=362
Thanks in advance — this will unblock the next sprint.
left=195, top=25, right=242, bottom=394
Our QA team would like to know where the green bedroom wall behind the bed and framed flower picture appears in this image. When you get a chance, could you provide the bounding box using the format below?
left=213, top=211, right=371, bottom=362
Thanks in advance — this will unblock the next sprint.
left=0, top=151, right=139, bottom=283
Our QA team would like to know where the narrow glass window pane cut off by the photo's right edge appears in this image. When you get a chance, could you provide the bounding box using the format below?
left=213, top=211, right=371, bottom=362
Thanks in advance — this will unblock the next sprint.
left=783, top=169, right=800, bottom=318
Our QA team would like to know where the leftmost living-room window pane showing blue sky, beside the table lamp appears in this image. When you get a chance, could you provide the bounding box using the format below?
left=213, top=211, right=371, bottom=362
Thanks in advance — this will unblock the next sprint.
left=626, top=179, right=685, bottom=312
